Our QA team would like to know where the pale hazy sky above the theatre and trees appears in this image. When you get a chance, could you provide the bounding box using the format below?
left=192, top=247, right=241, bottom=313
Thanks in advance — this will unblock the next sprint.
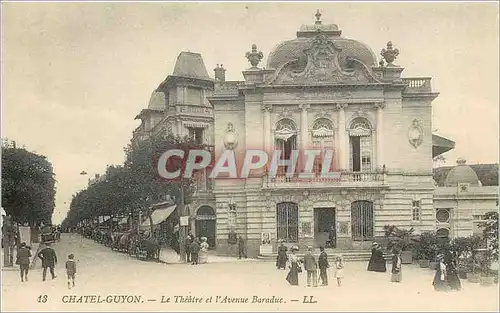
left=1, top=2, right=499, bottom=223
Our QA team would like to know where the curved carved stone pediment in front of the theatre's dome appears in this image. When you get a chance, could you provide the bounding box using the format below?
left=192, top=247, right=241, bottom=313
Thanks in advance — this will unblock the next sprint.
left=268, top=33, right=380, bottom=85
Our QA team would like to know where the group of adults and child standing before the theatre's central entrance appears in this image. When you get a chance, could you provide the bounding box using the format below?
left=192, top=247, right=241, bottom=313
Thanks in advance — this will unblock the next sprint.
left=276, top=241, right=344, bottom=287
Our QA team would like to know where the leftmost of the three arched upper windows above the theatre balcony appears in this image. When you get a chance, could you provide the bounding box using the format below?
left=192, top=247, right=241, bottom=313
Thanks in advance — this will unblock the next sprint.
left=274, top=118, right=297, bottom=173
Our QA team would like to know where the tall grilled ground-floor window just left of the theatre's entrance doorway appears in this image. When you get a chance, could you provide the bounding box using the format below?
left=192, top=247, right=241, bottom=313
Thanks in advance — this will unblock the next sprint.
left=276, top=202, right=299, bottom=242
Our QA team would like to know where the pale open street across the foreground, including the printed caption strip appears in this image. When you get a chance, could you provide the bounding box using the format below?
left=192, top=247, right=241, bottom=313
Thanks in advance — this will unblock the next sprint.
left=2, top=234, right=498, bottom=312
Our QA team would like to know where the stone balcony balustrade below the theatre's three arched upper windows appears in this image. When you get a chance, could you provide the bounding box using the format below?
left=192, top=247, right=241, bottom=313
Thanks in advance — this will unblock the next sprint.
left=263, top=172, right=384, bottom=187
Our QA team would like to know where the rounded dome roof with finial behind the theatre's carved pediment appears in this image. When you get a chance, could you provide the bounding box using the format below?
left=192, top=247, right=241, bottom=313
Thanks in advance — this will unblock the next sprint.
left=267, top=11, right=377, bottom=69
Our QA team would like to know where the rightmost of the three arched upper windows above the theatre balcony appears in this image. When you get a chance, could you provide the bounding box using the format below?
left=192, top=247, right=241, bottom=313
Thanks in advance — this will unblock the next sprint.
left=349, top=117, right=373, bottom=172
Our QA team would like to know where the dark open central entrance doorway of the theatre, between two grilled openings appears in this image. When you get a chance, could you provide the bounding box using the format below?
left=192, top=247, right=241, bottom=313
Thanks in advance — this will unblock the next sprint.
left=314, top=208, right=337, bottom=248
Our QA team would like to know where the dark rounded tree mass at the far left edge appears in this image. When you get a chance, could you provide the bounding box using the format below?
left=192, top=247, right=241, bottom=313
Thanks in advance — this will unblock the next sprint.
left=2, top=140, right=56, bottom=226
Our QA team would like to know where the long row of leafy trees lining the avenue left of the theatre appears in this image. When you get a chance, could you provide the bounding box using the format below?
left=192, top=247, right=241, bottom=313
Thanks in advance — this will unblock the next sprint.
left=63, top=136, right=204, bottom=250
